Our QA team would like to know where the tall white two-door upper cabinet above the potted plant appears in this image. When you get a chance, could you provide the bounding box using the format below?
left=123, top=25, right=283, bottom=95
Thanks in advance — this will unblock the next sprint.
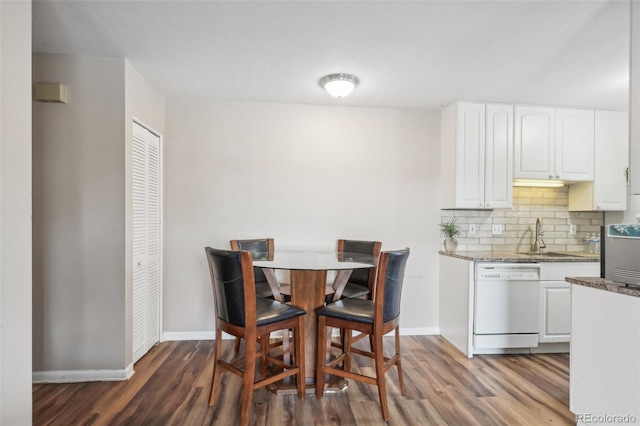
left=440, top=102, right=513, bottom=209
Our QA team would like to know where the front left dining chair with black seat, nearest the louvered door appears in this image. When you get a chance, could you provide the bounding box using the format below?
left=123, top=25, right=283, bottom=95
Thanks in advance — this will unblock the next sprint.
left=205, top=247, right=306, bottom=425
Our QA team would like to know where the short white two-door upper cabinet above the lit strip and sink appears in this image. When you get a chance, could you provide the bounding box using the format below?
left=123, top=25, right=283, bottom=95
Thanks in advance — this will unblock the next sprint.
left=513, top=106, right=594, bottom=182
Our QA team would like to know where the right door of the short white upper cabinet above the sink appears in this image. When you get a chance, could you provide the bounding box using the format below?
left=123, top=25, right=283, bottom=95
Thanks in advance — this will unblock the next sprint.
left=552, top=108, right=594, bottom=181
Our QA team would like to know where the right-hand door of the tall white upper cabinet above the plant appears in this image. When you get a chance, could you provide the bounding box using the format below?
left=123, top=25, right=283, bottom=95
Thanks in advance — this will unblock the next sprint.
left=484, top=105, right=513, bottom=208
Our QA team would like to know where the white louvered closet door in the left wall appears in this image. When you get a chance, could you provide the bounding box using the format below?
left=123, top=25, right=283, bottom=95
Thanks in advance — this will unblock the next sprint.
left=132, top=123, right=161, bottom=362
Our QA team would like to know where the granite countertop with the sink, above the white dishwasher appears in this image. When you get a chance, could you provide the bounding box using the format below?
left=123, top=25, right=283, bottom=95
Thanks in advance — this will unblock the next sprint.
left=439, top=251, right=600, bottom=263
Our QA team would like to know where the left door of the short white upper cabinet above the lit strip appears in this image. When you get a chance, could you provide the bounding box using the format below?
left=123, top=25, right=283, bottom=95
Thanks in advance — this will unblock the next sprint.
left=513, top=106, right=555, bottom=179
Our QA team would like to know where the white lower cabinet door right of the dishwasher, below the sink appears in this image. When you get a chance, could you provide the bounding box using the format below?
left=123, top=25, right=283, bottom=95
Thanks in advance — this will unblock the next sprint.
left=539, top=281, right=571, bottom=343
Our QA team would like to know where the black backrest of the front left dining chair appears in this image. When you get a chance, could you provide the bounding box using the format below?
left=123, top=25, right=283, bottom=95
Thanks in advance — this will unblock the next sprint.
left=204, top=247, right=256, bottom=327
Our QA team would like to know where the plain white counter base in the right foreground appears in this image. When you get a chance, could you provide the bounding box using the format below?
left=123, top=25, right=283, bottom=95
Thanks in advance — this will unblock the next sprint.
left=569, top=284, right=640, bottom=425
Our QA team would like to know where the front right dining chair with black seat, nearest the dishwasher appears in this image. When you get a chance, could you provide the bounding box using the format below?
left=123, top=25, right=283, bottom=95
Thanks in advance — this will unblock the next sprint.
left=316, top=248, right=409, bottom=420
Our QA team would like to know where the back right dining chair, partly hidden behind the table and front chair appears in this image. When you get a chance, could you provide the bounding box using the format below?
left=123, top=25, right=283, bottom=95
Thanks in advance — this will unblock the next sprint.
left=325, top=239, right=382, bottom=303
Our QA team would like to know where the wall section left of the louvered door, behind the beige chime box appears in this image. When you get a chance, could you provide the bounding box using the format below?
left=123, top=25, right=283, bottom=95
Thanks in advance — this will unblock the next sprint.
left=33, top=54, right=125, bottom=372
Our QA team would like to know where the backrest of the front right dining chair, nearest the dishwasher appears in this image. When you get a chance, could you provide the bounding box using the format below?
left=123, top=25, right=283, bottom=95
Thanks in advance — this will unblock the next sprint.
left=374, top=247, right=409, bottom=323
